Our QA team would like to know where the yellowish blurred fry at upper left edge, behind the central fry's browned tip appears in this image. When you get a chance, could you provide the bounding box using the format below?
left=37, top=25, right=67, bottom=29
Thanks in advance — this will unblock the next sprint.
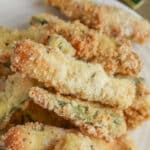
left=0, top=27, right=47, bottom=63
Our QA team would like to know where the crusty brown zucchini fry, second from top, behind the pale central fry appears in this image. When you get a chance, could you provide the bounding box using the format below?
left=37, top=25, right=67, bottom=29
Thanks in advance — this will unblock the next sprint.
left=31, top=14, right=142, bottom=76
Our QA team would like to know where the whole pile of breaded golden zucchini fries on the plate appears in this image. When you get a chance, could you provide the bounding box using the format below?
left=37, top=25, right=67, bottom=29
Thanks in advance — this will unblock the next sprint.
left=0, top=0, right=150, bottom=150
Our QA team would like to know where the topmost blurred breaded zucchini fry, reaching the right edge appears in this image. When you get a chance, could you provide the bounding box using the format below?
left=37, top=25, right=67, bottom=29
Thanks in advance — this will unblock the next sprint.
left=47, top=0, right=150, bottom=43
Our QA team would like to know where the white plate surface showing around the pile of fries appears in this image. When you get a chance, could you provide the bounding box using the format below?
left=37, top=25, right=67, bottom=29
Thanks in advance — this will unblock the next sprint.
left=0, top=0, right=150, bottom=150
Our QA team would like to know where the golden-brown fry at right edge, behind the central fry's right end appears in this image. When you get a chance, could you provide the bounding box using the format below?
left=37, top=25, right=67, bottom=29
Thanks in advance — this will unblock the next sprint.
left=125, top=79, right=150, bottom=129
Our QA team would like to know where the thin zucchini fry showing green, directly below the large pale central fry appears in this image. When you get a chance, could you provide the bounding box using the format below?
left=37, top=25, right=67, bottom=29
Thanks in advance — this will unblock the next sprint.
left=29, top=87, right=126, bottom=141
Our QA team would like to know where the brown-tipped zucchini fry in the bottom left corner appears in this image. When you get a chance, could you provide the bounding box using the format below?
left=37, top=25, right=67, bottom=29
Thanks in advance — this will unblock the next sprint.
left=4, top=123, right=65, bottom=150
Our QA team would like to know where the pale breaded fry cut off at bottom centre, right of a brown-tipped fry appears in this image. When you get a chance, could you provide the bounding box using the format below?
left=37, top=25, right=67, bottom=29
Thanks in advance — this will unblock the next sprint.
left=53, top=133, right=115, bottom=150
